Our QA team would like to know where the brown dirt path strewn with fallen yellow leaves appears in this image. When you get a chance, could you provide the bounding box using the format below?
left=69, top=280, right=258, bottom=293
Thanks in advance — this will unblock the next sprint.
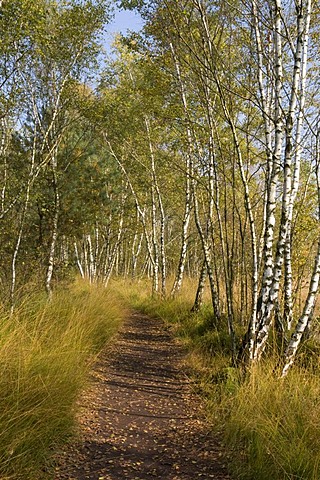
left=54, top=313, right=229, bottom=480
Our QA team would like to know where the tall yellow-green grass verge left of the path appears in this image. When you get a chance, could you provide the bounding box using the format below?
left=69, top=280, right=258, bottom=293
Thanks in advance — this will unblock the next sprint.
left=0, top=281, right=123, bottom=480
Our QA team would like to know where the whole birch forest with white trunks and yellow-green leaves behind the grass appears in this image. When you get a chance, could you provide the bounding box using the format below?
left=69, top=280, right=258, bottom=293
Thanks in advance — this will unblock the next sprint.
left=0, top=0, right=320, bottom=478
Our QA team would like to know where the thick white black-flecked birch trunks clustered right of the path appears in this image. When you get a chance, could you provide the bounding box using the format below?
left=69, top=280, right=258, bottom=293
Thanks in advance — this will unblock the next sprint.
left=253, top=1, right=311, bottom=358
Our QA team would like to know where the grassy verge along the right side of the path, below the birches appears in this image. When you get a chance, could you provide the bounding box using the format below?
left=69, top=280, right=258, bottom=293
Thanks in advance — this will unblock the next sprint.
left=118, top=284, right=320, bottom=480
